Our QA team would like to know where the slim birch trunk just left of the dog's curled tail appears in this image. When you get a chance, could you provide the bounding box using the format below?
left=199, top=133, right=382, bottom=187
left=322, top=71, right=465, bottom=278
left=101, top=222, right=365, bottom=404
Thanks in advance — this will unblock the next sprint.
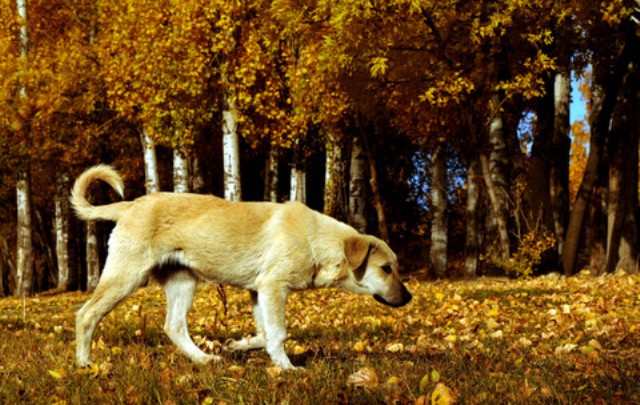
left=55, top=174, right=71, bottom=291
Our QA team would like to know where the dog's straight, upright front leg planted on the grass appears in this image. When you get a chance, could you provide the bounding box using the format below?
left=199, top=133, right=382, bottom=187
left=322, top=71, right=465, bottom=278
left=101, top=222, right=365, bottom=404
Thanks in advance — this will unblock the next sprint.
left=258, top=284, right=295, bottom=369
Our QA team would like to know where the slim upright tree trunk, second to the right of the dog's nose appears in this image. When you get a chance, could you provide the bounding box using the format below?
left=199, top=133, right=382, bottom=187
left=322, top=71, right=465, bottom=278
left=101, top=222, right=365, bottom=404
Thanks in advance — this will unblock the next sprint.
left=464, top=155, right=482, bottom=278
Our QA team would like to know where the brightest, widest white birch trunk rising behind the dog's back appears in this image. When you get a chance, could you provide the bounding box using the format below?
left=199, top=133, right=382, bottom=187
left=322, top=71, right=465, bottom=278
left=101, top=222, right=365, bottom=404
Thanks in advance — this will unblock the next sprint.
left=222, top=89, right=242, bottom=201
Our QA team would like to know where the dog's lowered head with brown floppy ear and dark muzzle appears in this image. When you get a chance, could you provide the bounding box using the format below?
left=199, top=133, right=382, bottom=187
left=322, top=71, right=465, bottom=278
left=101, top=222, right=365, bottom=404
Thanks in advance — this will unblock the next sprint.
left=340, top=235, right=412, bottom=307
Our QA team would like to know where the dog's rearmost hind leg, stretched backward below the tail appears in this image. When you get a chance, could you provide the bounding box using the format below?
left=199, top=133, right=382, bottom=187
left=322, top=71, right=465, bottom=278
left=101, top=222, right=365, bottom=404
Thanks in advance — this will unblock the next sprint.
left=76, top=249, right=151, bottom=367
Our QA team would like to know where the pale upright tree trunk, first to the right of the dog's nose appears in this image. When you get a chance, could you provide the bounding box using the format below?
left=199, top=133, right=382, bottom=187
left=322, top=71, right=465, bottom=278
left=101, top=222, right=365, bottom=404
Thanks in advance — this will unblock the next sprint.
left=429, top=143, right=449, bottom=278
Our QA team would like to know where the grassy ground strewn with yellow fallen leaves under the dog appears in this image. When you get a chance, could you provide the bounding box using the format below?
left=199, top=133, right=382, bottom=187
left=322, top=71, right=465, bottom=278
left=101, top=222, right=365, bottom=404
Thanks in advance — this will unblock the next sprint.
left=0, top=276, right=640, bottom=404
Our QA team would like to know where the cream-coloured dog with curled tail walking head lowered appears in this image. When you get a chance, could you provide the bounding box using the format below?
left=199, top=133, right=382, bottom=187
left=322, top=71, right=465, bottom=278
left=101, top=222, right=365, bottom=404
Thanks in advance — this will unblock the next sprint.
left=71, top=165, right=411, bottom=368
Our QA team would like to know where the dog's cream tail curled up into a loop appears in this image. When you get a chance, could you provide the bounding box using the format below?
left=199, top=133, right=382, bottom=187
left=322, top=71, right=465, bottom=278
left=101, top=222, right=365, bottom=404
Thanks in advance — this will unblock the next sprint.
left=71, top=165, right=132, bottom=221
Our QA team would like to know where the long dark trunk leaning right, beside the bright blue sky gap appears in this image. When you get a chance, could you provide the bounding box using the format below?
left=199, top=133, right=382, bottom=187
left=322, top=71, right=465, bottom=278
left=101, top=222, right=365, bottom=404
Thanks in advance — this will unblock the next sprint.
left=560, top=30, right=637, bottom=275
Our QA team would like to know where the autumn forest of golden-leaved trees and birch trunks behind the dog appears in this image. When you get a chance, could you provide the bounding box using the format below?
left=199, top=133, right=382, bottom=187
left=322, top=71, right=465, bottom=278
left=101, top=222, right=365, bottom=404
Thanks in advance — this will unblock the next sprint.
left=0, top=0, right=640, bottom=296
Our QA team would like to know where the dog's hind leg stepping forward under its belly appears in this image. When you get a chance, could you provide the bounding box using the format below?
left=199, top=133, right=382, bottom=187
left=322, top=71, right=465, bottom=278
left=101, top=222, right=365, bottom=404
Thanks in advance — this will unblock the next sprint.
left=164, top=270, right=220, bottom=363
